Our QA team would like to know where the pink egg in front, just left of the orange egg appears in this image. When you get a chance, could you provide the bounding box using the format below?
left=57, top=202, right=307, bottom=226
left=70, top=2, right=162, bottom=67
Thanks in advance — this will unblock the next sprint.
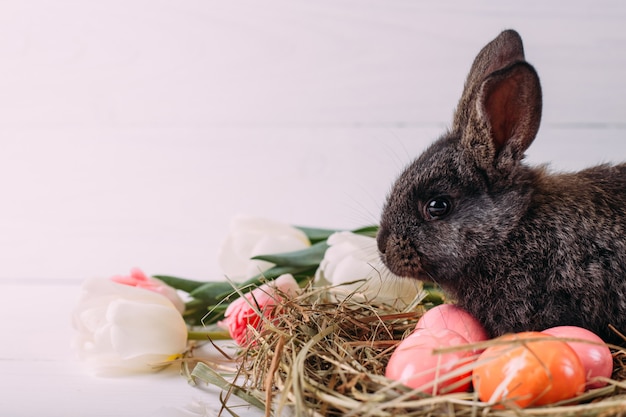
left=385, top=328, right=476, bottom=394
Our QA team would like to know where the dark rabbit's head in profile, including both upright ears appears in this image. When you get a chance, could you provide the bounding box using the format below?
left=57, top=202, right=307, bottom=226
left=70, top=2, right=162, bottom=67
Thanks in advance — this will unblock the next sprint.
left=378, top=30, right=541, bottom=287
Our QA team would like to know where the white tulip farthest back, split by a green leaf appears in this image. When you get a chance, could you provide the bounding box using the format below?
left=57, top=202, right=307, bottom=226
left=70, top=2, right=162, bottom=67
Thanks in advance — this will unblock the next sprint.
left=218, top=216, right=311, bottom=282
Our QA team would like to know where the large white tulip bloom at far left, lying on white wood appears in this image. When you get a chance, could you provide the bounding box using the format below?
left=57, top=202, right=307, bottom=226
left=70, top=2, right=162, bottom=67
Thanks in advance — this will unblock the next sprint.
left=72, top=279, right=187, bottom=375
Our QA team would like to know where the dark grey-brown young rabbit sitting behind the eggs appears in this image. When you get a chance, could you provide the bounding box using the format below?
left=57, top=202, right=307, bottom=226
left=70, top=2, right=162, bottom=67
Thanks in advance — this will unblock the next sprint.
left=377, top=30, right=626, bottom=345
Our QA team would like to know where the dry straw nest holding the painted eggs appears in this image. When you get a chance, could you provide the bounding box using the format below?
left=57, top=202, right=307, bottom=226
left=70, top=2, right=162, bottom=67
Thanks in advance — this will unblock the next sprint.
left=228, top=288, right=626, bottom=417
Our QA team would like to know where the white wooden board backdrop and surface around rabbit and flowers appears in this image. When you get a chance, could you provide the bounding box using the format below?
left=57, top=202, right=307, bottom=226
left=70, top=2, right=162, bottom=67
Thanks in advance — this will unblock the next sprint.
left=0, top=0, right=626, bottom=417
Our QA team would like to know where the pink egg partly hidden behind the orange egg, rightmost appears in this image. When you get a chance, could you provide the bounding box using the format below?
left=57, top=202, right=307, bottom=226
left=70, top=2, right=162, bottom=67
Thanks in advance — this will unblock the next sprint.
left=541, top=326, right=613, bottom=389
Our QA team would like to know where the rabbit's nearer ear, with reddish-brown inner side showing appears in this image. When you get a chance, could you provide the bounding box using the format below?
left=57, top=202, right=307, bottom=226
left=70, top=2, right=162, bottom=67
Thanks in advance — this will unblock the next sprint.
left=461, top=62, right=541, bottom=169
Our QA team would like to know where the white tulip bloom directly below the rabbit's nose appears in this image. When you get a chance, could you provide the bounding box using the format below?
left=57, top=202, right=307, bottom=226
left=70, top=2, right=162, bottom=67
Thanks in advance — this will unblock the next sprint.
left=316, top=232, right=422, bottom=305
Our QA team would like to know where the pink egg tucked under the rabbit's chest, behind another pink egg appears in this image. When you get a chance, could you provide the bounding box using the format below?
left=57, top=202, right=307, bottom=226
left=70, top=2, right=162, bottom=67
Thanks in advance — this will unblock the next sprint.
left=415, top=304, right=489, bottom=343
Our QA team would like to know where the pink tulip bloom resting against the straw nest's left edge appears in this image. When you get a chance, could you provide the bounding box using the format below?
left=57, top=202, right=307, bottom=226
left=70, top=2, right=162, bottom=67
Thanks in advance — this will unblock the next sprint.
left=219, top=274, right=300, bottom=346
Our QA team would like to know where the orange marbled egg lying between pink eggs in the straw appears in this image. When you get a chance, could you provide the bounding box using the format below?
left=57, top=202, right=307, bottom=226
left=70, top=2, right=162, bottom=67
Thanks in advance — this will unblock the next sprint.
left=472, top=332, right=585, bottom=408
